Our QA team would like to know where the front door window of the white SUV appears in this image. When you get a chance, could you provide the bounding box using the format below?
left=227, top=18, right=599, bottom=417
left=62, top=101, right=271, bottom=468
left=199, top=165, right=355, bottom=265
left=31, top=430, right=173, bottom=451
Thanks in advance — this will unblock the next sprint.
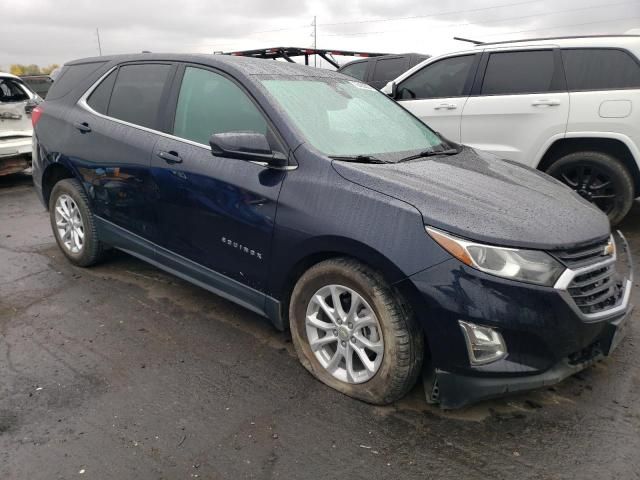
left=397, top=55, right=475, bottom=100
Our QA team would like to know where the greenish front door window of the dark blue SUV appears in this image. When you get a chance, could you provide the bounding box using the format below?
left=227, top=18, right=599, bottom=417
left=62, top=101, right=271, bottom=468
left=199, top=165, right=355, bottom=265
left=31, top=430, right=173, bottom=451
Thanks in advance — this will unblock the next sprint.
left=173, top=67, right=267, bottom=145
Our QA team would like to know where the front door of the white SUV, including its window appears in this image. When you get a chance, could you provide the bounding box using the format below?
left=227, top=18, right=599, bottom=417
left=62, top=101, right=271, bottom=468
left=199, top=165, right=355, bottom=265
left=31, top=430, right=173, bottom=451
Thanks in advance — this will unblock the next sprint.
left=395, top=53, right=480, bottom=142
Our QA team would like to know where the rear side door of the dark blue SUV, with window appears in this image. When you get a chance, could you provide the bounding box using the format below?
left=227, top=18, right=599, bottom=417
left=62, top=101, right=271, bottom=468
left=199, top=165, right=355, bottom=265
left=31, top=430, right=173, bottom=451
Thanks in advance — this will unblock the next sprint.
left=65, top=62, right=175, bottom=241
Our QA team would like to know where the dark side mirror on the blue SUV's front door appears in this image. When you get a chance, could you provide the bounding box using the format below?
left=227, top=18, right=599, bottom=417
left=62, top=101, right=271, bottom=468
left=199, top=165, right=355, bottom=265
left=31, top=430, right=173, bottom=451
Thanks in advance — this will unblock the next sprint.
left=209, top=132, right=288, bottom=169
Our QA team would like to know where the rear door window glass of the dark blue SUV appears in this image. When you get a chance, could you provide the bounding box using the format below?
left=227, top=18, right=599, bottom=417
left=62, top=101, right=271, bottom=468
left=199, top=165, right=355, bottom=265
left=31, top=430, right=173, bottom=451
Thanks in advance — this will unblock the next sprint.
left=107, top=63, right=171, bottom=128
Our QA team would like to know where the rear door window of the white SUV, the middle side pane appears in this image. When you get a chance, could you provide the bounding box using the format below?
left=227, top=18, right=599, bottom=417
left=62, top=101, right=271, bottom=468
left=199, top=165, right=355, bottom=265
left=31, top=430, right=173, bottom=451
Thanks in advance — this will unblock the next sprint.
left=482, top=50, right=555, bottom=95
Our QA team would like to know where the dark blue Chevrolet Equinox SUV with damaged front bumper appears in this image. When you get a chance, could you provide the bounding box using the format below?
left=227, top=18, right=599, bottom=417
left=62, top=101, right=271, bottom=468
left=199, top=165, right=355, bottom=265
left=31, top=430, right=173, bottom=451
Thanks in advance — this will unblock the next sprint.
left=33, top=54, right=631, bottom=408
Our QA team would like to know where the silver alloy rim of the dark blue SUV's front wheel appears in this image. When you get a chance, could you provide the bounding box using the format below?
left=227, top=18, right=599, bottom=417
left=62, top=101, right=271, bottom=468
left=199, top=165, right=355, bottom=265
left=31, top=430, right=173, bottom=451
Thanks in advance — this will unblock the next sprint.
left=305, top=285, right=384, bottom=383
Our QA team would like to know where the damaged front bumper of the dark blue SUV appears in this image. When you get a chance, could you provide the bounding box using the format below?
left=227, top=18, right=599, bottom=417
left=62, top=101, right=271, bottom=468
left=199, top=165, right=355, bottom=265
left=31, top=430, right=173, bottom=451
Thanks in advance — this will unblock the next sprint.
left=408, top=233, right=632, bottom=408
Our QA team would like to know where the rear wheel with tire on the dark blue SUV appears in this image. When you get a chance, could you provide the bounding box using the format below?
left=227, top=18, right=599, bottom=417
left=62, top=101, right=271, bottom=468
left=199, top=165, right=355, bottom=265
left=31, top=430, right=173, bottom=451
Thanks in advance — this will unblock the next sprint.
left=49, top=178, right=104, bottom=267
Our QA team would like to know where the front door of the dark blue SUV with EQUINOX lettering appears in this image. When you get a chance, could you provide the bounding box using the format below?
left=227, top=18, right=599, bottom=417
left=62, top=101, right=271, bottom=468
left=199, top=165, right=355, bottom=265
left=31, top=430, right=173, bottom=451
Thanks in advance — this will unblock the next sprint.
left=151, top=66, right=286, bottom=290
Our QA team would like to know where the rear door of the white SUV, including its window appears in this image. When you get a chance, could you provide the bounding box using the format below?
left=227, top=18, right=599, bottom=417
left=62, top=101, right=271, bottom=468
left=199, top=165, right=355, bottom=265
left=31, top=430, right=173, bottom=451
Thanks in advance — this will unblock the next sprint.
left=461, top=47, right=569, bottom=167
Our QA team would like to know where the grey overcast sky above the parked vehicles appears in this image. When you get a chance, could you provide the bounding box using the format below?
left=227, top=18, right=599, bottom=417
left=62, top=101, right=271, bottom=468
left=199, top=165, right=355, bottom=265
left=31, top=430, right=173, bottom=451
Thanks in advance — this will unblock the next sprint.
left=0, top=0, right=640, bottom=69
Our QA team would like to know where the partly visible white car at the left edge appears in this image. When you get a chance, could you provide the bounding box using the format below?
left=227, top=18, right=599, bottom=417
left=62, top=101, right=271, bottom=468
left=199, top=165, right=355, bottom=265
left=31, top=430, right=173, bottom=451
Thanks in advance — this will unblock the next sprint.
left=0, top=72, right=42, bottom=175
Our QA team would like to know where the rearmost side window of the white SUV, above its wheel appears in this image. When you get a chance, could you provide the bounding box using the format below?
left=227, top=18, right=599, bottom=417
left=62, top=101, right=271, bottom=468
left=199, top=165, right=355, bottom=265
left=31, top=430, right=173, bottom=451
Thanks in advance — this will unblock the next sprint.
left=562, top=48, right=640, bottom=91
